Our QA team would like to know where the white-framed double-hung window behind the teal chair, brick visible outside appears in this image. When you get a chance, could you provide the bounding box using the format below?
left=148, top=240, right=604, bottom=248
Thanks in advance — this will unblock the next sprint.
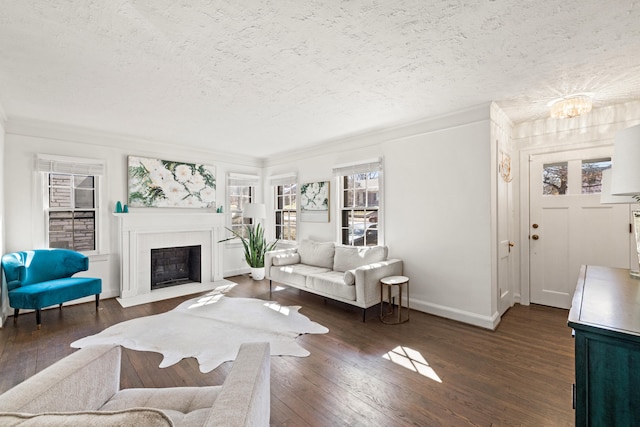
left=36, top=156, right=104, bottom=252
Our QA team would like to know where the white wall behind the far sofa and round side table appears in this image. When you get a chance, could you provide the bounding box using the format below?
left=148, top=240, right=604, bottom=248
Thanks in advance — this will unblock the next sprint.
left=265, top=105, right=498, bottom=328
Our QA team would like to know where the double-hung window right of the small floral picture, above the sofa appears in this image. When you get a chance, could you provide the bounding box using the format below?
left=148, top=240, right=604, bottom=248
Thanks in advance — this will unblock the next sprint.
left=333, top=159, right=383, bottom=246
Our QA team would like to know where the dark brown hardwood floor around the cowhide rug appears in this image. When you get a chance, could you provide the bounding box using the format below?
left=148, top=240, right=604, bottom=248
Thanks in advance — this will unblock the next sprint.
left=0, top=276, right=574, bottom=426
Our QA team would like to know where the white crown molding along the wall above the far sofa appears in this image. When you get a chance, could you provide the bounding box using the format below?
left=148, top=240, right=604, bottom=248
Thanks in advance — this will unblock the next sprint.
left=263, top=102, right=491, bottom=167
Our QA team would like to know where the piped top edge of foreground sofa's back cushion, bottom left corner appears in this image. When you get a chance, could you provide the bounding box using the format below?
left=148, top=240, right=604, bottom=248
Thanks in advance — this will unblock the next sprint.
left=0, top=408, right=174, bottom=427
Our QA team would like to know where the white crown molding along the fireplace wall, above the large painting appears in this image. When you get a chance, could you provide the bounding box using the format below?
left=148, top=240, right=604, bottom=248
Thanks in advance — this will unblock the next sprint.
left=5, top=117, right=263, bottom=168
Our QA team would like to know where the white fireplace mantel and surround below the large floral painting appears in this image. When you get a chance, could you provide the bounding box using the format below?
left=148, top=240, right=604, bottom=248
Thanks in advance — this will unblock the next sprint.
left=113, top=210, right=225, bottom=305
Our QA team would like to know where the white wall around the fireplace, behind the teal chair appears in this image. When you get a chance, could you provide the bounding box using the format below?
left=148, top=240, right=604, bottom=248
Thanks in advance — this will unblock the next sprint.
left=3, top=121, right=260, bottom=302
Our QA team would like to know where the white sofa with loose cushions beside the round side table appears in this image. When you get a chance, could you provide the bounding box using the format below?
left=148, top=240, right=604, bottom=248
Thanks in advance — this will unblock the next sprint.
left=264, top=240, right=402, bottom=321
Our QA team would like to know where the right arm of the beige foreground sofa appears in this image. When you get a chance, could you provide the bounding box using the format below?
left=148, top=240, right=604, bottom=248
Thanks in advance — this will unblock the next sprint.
left=205, top=342, right=271, bottom=427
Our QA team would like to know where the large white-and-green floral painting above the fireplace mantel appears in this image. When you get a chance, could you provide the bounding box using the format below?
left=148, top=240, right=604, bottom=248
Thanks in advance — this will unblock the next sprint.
left=129, top=156, right=216, bottom=208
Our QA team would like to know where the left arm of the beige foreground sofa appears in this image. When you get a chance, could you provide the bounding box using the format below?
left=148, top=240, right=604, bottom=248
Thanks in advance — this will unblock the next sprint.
left=0, top=345, right=122, bottom=414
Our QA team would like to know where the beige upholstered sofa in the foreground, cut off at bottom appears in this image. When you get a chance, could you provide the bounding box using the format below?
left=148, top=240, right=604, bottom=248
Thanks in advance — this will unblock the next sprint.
left=0, top=343, right=271, bottom=427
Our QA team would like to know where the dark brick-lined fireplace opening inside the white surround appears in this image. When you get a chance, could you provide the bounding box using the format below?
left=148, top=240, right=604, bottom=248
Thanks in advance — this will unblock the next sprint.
left=151, top=246, right=202, bottom=290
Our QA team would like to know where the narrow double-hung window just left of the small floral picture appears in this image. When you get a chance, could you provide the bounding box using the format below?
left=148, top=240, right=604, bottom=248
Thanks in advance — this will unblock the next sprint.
left=270, top=174, right=298, bottom=242
